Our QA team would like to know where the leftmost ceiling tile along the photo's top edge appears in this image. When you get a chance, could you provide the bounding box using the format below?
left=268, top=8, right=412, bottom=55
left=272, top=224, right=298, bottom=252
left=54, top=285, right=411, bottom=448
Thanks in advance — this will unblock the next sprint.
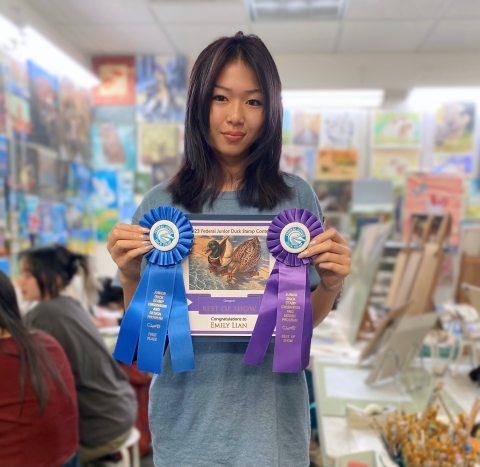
left=29, top=0, right=155, bottom=24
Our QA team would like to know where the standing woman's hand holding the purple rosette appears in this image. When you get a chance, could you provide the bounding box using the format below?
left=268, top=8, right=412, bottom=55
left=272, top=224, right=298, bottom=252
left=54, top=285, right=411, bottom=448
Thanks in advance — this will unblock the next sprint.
left=298, top=229, right=352, bottom=289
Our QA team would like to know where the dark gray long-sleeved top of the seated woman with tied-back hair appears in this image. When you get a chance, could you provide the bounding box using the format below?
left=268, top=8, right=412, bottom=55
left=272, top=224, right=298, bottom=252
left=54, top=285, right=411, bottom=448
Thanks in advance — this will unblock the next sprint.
left=26, top=296, right=137, bottom=447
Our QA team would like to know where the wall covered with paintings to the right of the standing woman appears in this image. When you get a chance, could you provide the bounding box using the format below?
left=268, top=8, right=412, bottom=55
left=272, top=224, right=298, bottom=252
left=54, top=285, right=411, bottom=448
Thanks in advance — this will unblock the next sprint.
left=282, top=104, right=480, bottom=246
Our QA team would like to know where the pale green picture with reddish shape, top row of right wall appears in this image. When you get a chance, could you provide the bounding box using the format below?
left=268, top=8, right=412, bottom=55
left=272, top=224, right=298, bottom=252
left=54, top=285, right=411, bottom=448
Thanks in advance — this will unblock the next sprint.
left=372, top=111, right=422, bottom=147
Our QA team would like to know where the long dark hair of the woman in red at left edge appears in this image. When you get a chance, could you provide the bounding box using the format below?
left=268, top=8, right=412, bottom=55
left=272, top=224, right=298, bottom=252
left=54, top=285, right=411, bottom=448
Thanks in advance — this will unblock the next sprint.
left=0, top=271, right=68, bottom=413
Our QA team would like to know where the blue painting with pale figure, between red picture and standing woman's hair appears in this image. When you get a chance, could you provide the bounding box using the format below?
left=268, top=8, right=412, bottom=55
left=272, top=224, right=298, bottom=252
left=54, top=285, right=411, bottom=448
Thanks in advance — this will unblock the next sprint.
left=136, top=55, right=187, bottom=123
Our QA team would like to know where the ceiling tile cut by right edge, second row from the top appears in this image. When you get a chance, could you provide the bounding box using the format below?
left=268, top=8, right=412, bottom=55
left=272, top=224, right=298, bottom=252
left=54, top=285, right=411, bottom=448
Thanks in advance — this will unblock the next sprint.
left=422, top=20, right=480, bottom=52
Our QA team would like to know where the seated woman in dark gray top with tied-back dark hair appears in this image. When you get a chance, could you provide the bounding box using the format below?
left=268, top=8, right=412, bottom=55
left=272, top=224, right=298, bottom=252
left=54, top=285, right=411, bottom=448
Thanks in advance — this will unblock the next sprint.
left=19, top=245, right=137, bottom=464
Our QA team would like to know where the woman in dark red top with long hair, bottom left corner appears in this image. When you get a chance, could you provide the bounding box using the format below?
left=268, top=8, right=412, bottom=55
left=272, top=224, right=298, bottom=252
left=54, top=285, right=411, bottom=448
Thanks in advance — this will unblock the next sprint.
left=0, top=272, right=80, bottom=467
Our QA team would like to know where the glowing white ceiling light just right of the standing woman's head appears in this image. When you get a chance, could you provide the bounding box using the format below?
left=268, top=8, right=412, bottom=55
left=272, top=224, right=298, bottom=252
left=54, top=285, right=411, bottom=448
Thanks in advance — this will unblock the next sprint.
left=282, top=89, right=385, bottom=109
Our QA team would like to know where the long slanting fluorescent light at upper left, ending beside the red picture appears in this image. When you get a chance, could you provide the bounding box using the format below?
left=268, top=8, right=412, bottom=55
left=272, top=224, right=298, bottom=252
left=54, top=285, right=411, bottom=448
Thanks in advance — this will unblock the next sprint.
left=24, top=26, right=100, bottom=88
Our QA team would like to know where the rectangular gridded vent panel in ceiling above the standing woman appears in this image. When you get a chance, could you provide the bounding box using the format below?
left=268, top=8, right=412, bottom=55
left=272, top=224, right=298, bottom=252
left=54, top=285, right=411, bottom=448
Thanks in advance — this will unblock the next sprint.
left=246, top=0, right=347, bottom=21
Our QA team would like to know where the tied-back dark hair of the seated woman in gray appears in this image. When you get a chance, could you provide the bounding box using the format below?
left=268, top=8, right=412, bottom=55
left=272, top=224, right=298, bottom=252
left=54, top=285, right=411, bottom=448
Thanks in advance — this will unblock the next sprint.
left=19, top=245, right=97, bottom=303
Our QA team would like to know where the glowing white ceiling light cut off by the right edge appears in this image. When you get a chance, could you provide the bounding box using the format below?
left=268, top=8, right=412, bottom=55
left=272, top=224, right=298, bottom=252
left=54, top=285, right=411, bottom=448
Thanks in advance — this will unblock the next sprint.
left=407, top=87, right=480, bottom=110
